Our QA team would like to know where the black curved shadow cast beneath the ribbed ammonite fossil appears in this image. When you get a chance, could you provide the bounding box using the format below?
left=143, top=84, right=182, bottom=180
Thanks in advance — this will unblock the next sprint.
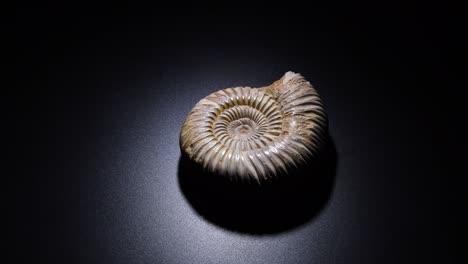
left=178, top=137, right=337, bottom=234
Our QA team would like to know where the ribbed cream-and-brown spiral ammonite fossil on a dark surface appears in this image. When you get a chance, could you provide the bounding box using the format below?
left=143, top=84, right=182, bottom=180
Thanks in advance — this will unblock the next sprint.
left=180, top=72, right=328, bottom=183
